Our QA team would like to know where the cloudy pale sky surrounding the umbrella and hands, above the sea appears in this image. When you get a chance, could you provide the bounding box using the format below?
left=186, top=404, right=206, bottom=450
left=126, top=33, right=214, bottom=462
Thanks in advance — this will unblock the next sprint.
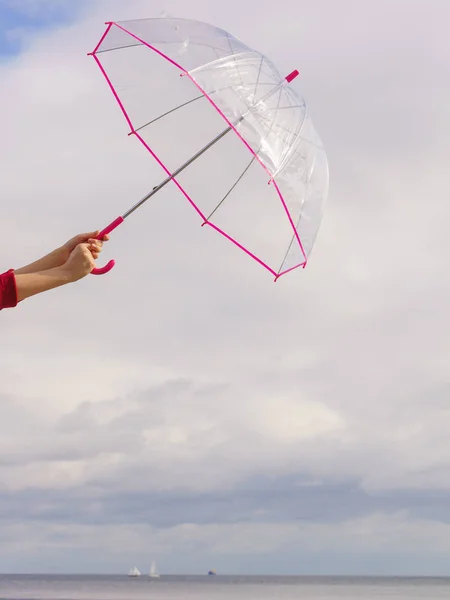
left=0, top=0, right=450, bottom=574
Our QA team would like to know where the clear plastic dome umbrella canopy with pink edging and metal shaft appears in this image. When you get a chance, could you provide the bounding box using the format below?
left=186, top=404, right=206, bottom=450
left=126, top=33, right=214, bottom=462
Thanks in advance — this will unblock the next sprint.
left=91, top=18, right=328, bottom=279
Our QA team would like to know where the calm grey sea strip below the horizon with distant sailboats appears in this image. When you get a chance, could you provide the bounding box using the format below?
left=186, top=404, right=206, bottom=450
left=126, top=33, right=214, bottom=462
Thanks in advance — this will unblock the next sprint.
left=0, top=575, right=450, bottom=600
